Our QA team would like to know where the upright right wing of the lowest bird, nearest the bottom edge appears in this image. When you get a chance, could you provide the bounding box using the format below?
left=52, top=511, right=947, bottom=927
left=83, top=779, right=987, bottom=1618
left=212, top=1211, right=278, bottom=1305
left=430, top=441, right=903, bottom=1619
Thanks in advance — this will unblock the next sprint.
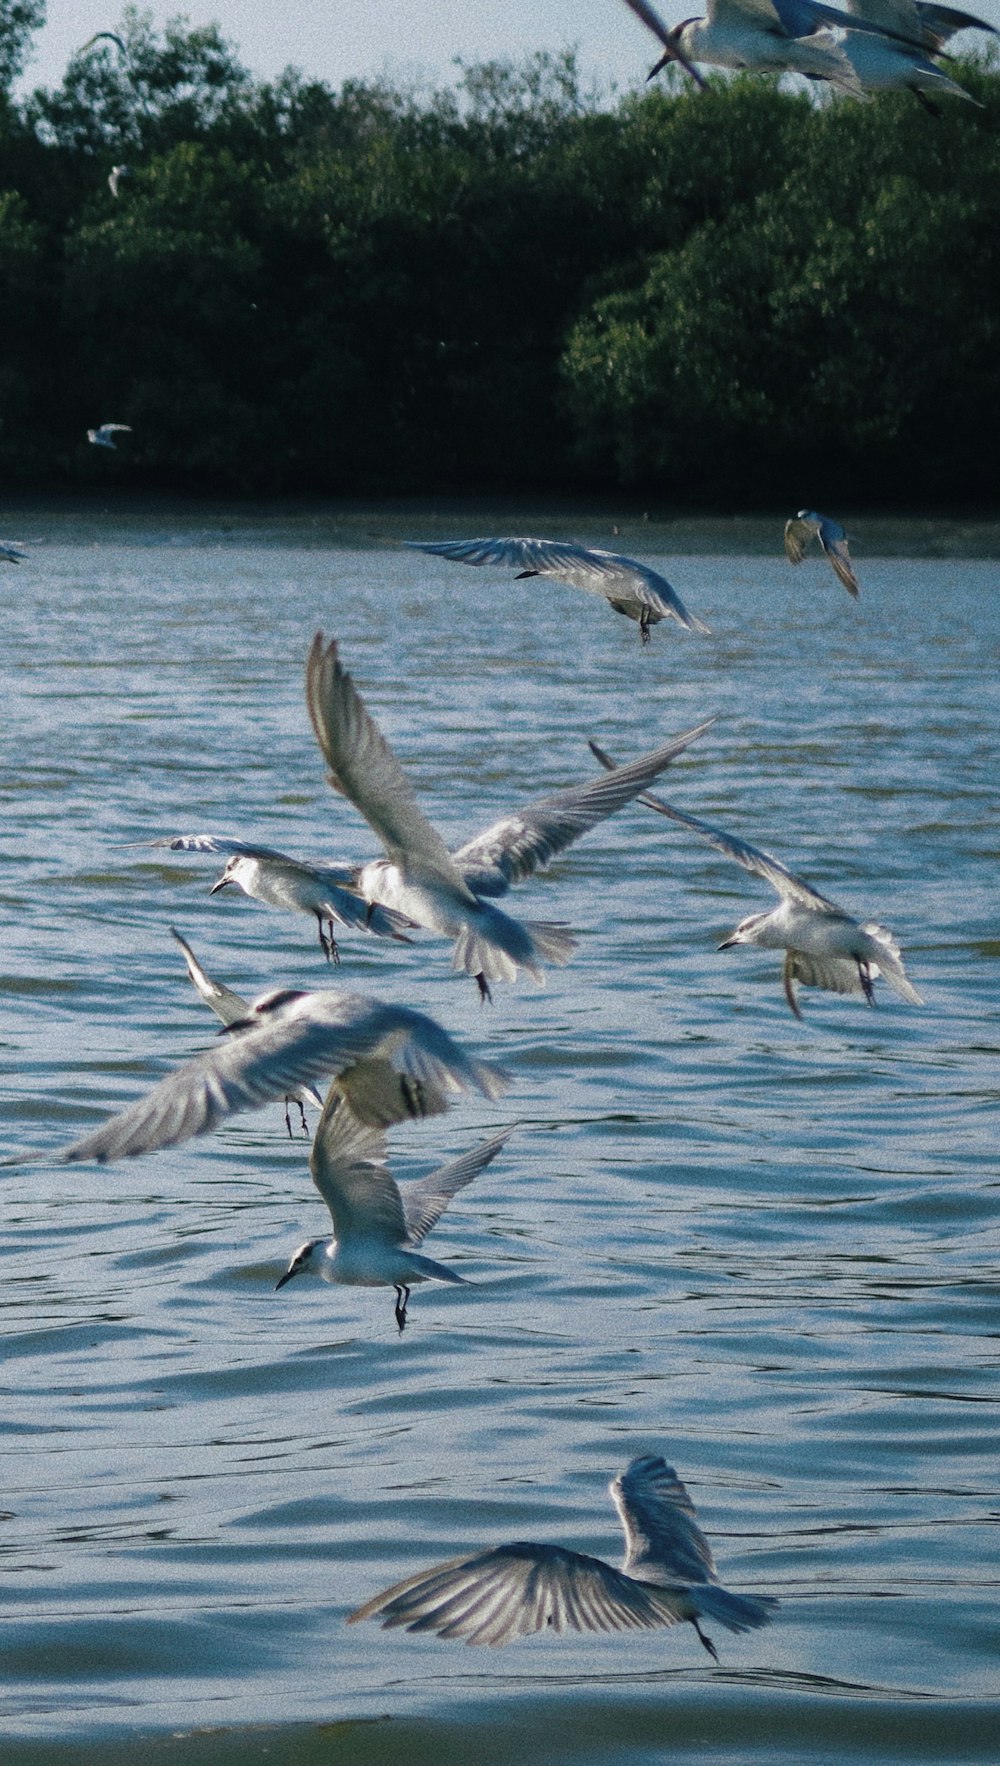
left=611, top=1453, right=716, bottom=1584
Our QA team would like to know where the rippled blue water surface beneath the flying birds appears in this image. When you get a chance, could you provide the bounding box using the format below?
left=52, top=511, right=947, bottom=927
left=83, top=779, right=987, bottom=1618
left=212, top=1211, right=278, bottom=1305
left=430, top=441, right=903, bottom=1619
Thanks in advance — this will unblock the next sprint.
left=0, top=512, right=1000, bottom=1766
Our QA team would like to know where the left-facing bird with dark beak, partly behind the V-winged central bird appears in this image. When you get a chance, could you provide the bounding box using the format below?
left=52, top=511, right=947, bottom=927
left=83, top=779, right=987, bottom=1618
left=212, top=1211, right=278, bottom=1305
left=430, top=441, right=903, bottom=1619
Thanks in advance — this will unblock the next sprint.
left=143, top=834, right=413, bottom=962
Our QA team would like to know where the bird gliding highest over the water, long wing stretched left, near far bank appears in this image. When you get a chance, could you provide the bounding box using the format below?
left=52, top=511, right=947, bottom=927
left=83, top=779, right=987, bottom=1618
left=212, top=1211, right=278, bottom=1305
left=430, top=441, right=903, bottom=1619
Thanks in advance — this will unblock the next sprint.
left=403, top=539, right=708, bottom=645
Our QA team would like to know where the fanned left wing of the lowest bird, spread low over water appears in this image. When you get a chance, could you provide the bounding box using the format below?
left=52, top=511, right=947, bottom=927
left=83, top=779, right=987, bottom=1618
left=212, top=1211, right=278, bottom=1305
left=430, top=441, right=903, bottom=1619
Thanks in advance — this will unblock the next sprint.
left=348, top=1542, right=686, bottom=1644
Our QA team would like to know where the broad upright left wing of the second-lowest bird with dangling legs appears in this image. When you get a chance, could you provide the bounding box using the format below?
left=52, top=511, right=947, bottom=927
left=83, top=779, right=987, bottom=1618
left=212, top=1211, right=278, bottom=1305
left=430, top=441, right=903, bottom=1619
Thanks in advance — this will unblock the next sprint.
left=309, top=1081, right=406, bottom=1245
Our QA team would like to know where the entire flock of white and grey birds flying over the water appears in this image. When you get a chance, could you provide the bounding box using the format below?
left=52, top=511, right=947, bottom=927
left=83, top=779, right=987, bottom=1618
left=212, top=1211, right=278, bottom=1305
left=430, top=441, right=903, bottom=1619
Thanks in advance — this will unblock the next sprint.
left=0, top=0, right=954, bottom=1657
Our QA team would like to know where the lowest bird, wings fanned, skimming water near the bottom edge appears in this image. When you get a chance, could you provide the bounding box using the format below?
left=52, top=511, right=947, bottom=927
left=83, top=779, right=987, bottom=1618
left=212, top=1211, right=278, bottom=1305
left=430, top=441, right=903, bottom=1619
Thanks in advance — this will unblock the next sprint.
left=348, top=1453, right=777, bottom=1662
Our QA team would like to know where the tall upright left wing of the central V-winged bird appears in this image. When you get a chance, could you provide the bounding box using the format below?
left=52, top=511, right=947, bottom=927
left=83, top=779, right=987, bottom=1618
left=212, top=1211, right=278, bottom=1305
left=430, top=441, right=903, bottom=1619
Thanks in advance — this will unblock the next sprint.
left=306, top=632, right=473, bottom=902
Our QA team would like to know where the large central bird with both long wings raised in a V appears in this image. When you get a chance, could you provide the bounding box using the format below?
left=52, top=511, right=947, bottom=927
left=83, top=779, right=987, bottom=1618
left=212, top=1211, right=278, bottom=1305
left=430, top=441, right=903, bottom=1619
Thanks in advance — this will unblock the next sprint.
left=306, top=632, right=710, bottom=1000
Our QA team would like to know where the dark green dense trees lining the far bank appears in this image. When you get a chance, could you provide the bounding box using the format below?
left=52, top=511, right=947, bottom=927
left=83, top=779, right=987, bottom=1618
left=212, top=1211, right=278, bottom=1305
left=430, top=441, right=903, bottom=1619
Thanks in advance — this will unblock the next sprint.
left=0, top=12, right=1000, bottom=507
